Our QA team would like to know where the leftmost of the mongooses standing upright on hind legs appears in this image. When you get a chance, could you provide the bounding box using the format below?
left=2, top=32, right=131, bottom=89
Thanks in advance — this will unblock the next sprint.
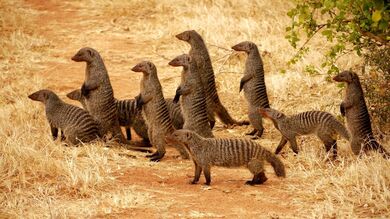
left=72, top=47, right=126, bottom=143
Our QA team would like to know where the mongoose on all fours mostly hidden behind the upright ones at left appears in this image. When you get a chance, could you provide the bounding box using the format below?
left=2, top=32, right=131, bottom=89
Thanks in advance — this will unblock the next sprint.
left=66, top=89, right=184, bottom=141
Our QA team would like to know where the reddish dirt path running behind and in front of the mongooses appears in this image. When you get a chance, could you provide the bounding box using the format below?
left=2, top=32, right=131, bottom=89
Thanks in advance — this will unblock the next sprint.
left=27, top=0, right=296, bottom=218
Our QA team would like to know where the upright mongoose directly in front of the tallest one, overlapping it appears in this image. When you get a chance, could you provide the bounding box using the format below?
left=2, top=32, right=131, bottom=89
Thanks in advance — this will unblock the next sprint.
left=169, top=54, right=214, bottom=138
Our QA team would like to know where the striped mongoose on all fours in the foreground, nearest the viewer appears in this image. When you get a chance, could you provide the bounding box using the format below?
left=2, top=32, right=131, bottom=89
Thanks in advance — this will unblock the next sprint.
left=167, top=129, right=286, bottom=185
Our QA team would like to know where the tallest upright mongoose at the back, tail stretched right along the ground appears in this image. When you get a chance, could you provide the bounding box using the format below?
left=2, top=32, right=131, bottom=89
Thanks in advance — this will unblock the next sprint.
left=176, top=30, right=249, bottom=128
